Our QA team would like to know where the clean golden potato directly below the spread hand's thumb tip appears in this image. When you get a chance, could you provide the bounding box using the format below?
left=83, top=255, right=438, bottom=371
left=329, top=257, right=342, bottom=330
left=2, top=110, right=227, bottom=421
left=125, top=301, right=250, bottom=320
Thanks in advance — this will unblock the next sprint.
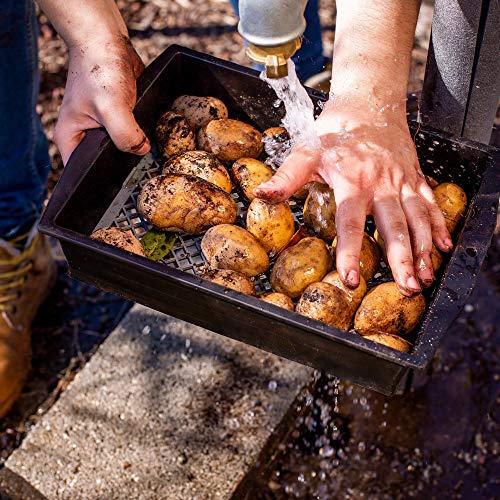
left=247, top=198, right=295, bottom=258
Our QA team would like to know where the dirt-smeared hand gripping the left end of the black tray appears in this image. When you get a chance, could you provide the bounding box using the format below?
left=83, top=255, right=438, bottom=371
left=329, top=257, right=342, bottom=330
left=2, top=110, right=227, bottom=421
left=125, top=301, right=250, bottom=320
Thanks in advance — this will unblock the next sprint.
left=54, top=34, right=151, bottom=164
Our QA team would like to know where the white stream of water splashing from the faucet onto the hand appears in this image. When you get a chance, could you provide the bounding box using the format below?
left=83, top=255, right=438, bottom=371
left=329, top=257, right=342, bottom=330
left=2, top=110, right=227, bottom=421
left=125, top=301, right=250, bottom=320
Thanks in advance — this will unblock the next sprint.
left=260, top=59, right=320, bottom=148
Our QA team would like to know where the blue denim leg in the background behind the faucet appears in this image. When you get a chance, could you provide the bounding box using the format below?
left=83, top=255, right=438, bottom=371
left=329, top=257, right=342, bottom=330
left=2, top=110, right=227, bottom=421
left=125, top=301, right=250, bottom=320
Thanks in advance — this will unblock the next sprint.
left=231, top=0, right=325, bottom=82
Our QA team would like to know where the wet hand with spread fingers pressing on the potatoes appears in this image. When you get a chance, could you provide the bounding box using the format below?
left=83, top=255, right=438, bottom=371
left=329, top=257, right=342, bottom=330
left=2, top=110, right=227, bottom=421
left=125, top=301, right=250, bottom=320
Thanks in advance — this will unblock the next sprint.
left=254, top=98, right=452, bottom=296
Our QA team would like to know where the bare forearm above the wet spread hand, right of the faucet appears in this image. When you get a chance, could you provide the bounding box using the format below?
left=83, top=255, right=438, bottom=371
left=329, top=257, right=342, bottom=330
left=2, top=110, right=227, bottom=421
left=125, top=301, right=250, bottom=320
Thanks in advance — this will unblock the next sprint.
left=331, top=0, right=420, bottom=106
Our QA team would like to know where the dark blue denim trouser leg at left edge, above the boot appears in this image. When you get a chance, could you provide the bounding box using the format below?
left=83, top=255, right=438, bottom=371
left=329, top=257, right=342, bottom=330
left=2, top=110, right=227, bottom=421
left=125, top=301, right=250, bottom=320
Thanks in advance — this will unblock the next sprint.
left=0, top=0, right=50, bottom=239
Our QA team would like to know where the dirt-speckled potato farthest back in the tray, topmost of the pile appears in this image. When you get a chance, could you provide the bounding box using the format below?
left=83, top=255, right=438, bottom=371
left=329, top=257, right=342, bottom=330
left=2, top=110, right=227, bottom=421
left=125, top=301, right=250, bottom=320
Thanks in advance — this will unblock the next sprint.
left=172, top=95, right=228, bottom=129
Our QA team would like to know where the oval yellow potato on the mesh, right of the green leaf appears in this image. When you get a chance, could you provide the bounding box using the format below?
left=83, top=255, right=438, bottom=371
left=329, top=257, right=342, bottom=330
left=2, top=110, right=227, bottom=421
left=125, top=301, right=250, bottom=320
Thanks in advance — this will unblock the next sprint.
left=201, top=224, right=269, bottom=277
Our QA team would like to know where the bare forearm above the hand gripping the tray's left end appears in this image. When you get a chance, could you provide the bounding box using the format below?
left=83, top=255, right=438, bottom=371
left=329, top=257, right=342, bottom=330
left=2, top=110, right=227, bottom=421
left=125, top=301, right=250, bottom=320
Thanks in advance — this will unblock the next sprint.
left=38, top=0, right=127, bottom=50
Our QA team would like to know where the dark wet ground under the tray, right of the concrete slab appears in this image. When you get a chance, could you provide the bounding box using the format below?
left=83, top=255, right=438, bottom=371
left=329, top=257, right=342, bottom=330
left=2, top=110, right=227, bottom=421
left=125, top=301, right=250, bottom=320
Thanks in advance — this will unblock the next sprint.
left=235, top=233, right=500, bottom=499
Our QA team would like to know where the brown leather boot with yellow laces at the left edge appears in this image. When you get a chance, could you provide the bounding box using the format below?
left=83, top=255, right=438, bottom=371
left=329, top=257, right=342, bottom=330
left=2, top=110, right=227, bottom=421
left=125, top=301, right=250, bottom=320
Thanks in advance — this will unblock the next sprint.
left=0, top=233, right=56, bottom=418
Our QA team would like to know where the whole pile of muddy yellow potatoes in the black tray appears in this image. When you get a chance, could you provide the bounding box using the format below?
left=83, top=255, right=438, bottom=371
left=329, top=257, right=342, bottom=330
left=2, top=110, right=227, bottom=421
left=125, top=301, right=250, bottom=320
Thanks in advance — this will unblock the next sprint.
left=92, top=95, right=467, bottom=352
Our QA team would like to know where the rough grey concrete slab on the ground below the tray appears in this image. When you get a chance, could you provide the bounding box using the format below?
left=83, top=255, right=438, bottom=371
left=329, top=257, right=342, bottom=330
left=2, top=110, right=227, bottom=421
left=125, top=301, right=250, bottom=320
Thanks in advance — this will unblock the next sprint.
left=6, top=306, right=310, bottom=500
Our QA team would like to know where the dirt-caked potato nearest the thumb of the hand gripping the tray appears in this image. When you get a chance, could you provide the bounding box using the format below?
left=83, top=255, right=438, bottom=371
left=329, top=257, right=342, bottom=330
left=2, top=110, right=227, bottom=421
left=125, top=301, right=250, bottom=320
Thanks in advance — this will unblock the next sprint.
left=155, top=111, right=196, bottom=158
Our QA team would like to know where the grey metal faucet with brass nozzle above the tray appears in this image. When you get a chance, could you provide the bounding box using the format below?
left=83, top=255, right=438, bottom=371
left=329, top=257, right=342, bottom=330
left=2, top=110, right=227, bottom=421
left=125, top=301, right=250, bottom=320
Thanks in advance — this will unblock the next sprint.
left=238, top=0, right=307, bottom=78
